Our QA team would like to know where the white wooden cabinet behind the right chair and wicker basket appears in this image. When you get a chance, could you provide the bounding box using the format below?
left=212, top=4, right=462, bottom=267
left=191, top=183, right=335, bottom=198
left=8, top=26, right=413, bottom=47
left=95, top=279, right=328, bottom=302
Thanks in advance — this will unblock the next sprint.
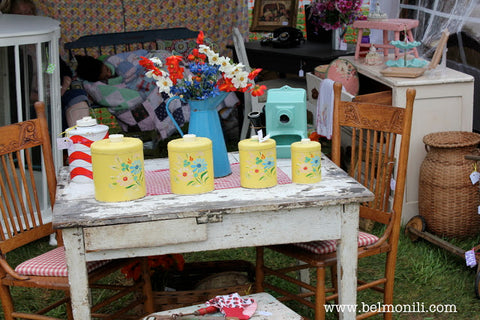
left=344, top=57, right=474, bottom=223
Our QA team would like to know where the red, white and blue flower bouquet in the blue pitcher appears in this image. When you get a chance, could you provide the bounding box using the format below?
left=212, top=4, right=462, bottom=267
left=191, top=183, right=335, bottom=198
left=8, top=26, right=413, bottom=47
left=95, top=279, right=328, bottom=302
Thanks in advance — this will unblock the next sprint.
left=140, top=31, right=266, bottom=100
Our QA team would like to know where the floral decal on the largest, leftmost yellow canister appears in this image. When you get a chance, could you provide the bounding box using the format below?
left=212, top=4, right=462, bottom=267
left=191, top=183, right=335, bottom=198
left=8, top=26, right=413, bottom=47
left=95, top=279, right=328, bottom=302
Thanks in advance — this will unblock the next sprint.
left=110, top=153, right=145, bottom=190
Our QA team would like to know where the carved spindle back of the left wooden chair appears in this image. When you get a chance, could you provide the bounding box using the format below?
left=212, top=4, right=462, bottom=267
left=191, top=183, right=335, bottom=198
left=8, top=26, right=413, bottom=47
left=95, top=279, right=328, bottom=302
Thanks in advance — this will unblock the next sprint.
left=0, top=102, right=56, bottom=254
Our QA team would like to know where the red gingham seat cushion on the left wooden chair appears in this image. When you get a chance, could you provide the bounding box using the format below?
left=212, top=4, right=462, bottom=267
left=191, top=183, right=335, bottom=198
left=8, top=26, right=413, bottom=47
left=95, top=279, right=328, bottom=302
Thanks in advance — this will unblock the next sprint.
left=15, top=247, right=108, bottom=277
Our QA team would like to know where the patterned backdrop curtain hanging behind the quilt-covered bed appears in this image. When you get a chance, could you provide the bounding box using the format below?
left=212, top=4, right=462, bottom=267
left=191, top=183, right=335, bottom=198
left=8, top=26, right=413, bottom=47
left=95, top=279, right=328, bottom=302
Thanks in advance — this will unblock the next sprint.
left=36, top=0, right=248, bottom=55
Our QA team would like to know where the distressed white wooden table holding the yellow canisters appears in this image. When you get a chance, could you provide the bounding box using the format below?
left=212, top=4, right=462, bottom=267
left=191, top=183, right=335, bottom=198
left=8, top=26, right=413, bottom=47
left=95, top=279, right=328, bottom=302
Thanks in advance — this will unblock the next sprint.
left=53, top=153, right=374, bottom=320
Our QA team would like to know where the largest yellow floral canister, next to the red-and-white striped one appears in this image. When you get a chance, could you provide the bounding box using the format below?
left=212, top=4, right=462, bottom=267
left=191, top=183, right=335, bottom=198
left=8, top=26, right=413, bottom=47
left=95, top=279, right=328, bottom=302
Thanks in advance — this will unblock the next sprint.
left=91, top=134, right=146, bottom=202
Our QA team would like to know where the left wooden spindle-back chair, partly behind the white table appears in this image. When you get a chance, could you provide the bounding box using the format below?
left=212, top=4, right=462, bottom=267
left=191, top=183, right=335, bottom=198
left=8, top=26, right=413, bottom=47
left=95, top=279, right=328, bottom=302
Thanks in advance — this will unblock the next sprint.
left=0, top=102, right=154, bottom=320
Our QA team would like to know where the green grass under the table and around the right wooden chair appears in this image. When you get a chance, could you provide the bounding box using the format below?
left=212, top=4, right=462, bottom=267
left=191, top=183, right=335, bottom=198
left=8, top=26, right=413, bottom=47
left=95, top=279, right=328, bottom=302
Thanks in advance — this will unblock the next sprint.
left=186, top=225, right=480, bottom=320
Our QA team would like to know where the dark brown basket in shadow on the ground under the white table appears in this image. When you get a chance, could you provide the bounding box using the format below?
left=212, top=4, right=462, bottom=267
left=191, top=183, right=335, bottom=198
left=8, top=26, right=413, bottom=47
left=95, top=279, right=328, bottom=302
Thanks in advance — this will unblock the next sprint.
left=154, top=260, right=255, bottom=311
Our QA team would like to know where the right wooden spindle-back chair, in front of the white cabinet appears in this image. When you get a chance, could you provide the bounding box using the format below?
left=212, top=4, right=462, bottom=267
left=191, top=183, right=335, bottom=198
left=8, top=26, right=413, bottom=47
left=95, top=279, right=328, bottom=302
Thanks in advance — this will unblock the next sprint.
left=256, top=82, right=415, bottom=320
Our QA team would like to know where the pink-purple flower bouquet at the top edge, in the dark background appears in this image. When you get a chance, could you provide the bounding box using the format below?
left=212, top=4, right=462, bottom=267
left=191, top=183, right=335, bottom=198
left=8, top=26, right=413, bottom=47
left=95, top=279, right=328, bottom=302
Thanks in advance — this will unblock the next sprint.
left=310, top=0, right=363, bottom=30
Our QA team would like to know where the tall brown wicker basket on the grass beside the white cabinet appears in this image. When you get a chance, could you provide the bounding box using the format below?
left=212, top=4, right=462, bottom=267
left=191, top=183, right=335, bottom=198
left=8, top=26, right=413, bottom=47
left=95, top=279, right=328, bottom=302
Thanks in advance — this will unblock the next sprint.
left=418, top=131, right=480, bottom=238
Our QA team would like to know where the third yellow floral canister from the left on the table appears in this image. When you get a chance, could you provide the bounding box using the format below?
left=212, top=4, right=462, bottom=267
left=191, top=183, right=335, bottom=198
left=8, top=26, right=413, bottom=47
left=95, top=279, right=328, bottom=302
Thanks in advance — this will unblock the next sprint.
left=238, top=136, right=277, bottom=188
